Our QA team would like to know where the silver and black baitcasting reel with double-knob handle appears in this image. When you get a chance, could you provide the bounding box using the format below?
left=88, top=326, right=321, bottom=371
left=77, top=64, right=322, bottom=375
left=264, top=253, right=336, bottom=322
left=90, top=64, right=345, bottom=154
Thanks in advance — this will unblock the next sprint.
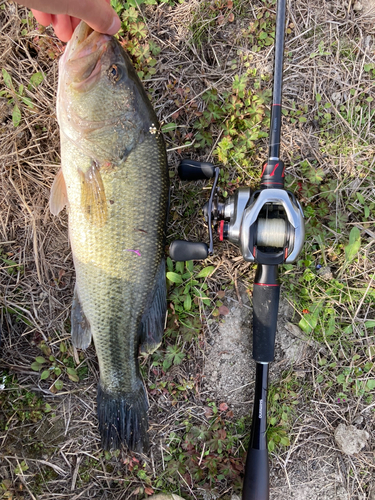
left=169, top=159, right=305, bottom=265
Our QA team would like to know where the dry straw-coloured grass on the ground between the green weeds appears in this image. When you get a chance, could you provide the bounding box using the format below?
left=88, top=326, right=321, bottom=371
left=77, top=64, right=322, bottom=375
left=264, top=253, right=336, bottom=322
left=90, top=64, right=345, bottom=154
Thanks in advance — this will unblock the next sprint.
left=0, top=0, right=375, bottom=500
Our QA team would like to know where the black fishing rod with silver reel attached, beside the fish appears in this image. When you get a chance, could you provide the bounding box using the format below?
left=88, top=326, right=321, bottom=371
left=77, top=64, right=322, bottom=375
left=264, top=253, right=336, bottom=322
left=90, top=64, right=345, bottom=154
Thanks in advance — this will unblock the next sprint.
left=169, top=0, right=305, bottom=500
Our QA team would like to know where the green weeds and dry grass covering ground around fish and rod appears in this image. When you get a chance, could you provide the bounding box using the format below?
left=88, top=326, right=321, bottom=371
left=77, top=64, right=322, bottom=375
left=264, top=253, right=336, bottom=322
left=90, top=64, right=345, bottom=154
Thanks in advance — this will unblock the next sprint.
left=0, top=0, right=375, bottom=500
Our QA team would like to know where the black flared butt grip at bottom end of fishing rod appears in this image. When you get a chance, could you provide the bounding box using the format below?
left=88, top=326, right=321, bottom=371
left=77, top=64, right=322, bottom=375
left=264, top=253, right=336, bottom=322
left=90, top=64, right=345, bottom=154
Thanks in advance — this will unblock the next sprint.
left=242, top=448, right=269, bottom=500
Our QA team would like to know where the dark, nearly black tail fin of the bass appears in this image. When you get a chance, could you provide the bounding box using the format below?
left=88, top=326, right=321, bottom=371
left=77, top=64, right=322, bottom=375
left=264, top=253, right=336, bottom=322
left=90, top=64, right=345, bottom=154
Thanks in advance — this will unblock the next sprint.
left=97, top=380, right=149, bottom=453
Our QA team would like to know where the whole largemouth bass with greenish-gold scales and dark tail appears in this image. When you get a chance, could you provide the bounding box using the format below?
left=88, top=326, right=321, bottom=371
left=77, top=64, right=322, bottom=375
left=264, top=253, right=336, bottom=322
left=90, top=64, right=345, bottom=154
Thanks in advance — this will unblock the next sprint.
left=50, top=22, right=168, bottom=452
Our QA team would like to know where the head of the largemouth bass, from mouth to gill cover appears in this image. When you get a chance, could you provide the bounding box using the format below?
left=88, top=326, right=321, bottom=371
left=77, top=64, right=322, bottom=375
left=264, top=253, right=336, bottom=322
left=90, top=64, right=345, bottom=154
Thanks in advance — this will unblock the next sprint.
left=57, top=21, right=151, bottom=163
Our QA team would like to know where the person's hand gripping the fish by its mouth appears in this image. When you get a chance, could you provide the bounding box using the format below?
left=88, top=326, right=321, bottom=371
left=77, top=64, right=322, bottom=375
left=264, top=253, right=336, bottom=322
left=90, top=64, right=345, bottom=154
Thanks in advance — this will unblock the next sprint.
left=17, top=0, right=121, bottom=42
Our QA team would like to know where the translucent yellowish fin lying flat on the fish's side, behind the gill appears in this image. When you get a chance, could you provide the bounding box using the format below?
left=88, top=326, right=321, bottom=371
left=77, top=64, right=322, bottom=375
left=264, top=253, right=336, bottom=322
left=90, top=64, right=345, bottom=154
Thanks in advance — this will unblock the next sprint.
left=79, top=161, right=107, bottom=226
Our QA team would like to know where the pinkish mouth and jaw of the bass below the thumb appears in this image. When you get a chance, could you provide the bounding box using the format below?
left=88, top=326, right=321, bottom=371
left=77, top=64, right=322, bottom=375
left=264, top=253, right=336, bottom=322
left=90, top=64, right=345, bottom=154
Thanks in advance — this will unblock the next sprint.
left=64, top=21, right=112, bottom=92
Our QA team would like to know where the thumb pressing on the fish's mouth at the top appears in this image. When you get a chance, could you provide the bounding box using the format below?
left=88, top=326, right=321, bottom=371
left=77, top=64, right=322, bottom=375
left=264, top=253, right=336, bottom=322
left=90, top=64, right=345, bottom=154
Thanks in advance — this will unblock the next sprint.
left=66, top=0, right=121, bottom=35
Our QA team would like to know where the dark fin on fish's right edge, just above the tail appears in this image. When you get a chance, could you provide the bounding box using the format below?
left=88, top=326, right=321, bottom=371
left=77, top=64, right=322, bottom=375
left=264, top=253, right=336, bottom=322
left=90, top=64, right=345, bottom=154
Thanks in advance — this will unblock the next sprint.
left=140, top=258, right=167, bottom=354
